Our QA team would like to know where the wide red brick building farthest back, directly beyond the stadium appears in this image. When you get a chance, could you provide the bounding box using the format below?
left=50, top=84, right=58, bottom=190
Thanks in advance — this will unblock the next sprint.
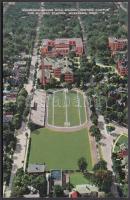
left=41, top=38, right=83, bottom=57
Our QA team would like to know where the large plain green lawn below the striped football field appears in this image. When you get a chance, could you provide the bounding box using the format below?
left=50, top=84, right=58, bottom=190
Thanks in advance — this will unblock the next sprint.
left=29, top=128, right=92, bottom=170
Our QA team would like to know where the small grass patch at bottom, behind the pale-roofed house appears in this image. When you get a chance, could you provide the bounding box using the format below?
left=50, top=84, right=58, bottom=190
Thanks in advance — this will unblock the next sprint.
left=70, top=172, right=90, bottom=186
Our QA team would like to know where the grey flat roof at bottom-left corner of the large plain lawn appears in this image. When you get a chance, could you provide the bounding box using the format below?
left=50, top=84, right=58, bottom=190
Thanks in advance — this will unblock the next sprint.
left=27, top=164, right=45, bottom=173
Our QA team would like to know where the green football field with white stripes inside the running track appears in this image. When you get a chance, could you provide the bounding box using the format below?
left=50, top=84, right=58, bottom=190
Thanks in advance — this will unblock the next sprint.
left=48, top=90, right=86, bottom=127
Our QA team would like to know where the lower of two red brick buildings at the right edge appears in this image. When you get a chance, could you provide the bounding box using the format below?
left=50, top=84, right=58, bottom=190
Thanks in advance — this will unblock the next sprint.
left=116, top=60, right=128, bottom=76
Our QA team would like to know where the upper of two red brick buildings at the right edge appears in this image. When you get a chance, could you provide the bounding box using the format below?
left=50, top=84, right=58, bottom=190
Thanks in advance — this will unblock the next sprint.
left=108, top=37, right=128, bottom=54
